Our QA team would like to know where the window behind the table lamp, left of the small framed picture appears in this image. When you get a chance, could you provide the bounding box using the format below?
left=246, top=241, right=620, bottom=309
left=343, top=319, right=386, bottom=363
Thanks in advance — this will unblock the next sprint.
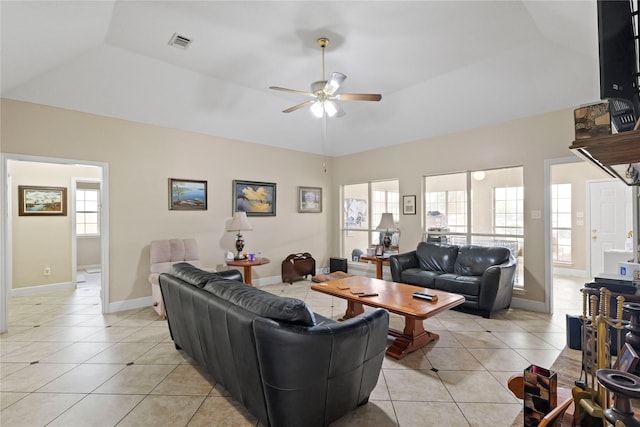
left=342, top=180, right=400, bottom=260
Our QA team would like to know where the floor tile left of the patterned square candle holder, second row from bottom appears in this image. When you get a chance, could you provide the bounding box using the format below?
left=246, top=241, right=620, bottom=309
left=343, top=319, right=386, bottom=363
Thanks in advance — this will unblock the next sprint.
left=438, top=371, right=518, bottom=403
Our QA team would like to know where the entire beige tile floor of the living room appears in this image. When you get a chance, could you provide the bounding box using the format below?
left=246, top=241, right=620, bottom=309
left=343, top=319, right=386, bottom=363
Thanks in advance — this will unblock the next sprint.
left=0, top=274, right=584, bottom=427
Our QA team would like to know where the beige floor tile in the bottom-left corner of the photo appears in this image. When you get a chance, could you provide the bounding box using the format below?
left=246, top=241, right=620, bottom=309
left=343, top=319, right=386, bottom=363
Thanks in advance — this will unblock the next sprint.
left=0, top=393, right=84, bottom=427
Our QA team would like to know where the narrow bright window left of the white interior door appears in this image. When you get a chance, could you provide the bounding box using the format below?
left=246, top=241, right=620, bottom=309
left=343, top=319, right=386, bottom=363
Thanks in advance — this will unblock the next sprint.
left=551, top=184, right=572, bottom=263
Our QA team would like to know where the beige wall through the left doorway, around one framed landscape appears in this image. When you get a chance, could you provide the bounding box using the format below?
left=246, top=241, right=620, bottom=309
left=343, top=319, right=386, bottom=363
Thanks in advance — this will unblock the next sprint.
left=9, top=160, right=99, bottom=288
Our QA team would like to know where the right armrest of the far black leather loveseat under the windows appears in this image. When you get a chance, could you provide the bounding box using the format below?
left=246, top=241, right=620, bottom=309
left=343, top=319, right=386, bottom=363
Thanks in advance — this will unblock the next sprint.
left=478, top=256, right=517, bottom=312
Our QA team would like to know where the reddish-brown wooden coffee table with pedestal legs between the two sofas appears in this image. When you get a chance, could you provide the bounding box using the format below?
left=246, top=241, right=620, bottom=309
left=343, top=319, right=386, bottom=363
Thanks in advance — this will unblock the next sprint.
left=311, top=276, right=464, bottom=359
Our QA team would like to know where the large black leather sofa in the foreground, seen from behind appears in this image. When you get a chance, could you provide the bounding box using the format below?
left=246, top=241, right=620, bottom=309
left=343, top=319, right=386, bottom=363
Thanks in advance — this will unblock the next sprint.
left=159, top=263, right=389, bottom=427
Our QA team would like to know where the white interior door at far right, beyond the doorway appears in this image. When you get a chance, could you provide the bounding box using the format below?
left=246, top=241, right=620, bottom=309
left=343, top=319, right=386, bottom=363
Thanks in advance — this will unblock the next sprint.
left=589, top=180, right=632, bottom=276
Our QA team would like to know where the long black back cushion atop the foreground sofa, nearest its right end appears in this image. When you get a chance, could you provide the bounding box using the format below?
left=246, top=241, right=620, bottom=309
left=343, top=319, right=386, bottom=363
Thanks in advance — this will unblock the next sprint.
left=203, top=279, right=316, bottom=326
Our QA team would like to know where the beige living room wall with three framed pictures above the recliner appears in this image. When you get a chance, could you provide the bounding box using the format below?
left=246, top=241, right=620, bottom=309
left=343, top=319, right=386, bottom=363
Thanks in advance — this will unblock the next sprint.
left=1, top=99, right=335, bottom=302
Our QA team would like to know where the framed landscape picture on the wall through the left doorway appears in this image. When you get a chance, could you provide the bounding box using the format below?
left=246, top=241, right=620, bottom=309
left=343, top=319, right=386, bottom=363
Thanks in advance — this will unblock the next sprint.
left=18, top=185, right=67, bottom=216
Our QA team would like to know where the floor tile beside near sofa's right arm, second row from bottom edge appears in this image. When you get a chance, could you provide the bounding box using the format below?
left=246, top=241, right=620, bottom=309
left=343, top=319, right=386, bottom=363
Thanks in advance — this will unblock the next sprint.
left=384, top=369, right=453, bottom=402
